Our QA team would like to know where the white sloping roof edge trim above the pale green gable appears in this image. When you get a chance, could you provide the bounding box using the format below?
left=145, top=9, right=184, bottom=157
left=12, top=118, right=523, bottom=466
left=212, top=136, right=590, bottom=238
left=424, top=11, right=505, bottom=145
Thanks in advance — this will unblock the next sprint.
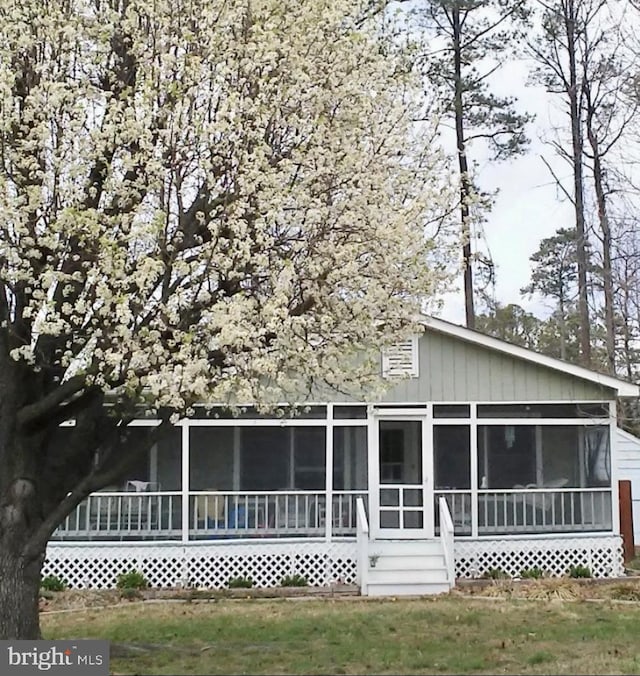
left=419, top=315, right=640, bottom=397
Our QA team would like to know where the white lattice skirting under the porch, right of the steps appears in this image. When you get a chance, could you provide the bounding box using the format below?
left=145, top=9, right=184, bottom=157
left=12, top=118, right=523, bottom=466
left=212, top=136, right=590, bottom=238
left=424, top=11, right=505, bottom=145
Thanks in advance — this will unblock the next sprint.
left=455, top=535, right=624, bottom=578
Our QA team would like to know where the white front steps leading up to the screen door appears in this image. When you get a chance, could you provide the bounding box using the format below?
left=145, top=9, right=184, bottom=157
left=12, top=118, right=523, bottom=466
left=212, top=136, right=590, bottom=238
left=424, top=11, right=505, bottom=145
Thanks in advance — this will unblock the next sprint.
left=366, top=539, right=451, bottom=596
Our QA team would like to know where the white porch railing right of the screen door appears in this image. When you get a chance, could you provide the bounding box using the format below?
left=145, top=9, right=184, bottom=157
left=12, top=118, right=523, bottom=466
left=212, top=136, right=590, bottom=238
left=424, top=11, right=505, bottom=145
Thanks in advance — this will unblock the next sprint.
left=436, top=488, right=612, bottom=535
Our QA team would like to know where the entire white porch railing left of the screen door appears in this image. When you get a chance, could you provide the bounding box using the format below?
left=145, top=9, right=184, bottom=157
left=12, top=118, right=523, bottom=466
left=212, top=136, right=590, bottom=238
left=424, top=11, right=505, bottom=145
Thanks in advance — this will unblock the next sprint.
left=53, top=491, right=367, bottom=540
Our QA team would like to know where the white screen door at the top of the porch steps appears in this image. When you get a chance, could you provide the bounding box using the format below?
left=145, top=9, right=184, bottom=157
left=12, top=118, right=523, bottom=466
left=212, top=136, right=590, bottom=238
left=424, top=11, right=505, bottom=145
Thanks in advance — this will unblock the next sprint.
left=371, top=415, right=434, bottom=539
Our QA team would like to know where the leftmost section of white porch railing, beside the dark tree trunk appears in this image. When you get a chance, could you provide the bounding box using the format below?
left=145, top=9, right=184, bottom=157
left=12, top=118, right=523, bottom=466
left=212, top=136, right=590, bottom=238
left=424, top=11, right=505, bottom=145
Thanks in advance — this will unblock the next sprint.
left=53, top=491, right=182, bottom=540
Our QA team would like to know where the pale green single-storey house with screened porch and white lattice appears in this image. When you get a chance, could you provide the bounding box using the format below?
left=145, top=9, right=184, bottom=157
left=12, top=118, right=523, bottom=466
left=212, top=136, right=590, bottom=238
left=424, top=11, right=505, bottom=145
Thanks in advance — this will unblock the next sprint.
left=44, top=317, right=639, bottom=594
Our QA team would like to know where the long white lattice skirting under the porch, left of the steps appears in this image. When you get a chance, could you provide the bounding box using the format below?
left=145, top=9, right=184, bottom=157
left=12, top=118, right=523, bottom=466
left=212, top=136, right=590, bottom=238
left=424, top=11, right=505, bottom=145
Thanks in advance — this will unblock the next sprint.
left=42, top=541, right=357, bottom=589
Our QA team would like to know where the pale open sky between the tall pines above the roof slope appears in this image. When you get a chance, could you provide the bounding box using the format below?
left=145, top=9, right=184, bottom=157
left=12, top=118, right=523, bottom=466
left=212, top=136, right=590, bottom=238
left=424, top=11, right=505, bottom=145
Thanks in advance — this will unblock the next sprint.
left=439, top=61, right=573, bottom=324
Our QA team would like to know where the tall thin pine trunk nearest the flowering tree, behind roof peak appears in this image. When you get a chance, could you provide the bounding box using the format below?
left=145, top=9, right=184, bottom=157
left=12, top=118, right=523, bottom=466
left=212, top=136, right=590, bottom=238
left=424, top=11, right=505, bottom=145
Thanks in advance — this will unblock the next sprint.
left=451, top=7, right=476, bottom=329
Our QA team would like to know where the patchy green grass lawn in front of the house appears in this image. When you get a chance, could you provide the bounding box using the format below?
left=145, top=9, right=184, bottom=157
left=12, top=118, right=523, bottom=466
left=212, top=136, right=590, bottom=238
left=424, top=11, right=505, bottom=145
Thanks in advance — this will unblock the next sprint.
left=42, top=597, right=640, bottom=674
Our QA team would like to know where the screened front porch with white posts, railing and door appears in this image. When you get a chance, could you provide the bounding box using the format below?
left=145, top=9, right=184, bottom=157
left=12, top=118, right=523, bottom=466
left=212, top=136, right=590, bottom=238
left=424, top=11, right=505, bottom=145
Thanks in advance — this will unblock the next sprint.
left=55, top=403, right=613, bottom=540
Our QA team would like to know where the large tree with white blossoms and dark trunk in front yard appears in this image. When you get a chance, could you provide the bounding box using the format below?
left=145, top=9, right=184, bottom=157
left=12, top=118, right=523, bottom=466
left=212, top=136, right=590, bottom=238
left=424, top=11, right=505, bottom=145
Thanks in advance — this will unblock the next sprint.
left=0, top=0, right=449, bottom=638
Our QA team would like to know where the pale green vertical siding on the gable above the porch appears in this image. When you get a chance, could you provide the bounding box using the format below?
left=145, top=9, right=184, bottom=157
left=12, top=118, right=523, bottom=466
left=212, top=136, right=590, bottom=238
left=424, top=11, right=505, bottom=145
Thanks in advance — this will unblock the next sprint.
left=383, top=331, right=615, bottom=403
